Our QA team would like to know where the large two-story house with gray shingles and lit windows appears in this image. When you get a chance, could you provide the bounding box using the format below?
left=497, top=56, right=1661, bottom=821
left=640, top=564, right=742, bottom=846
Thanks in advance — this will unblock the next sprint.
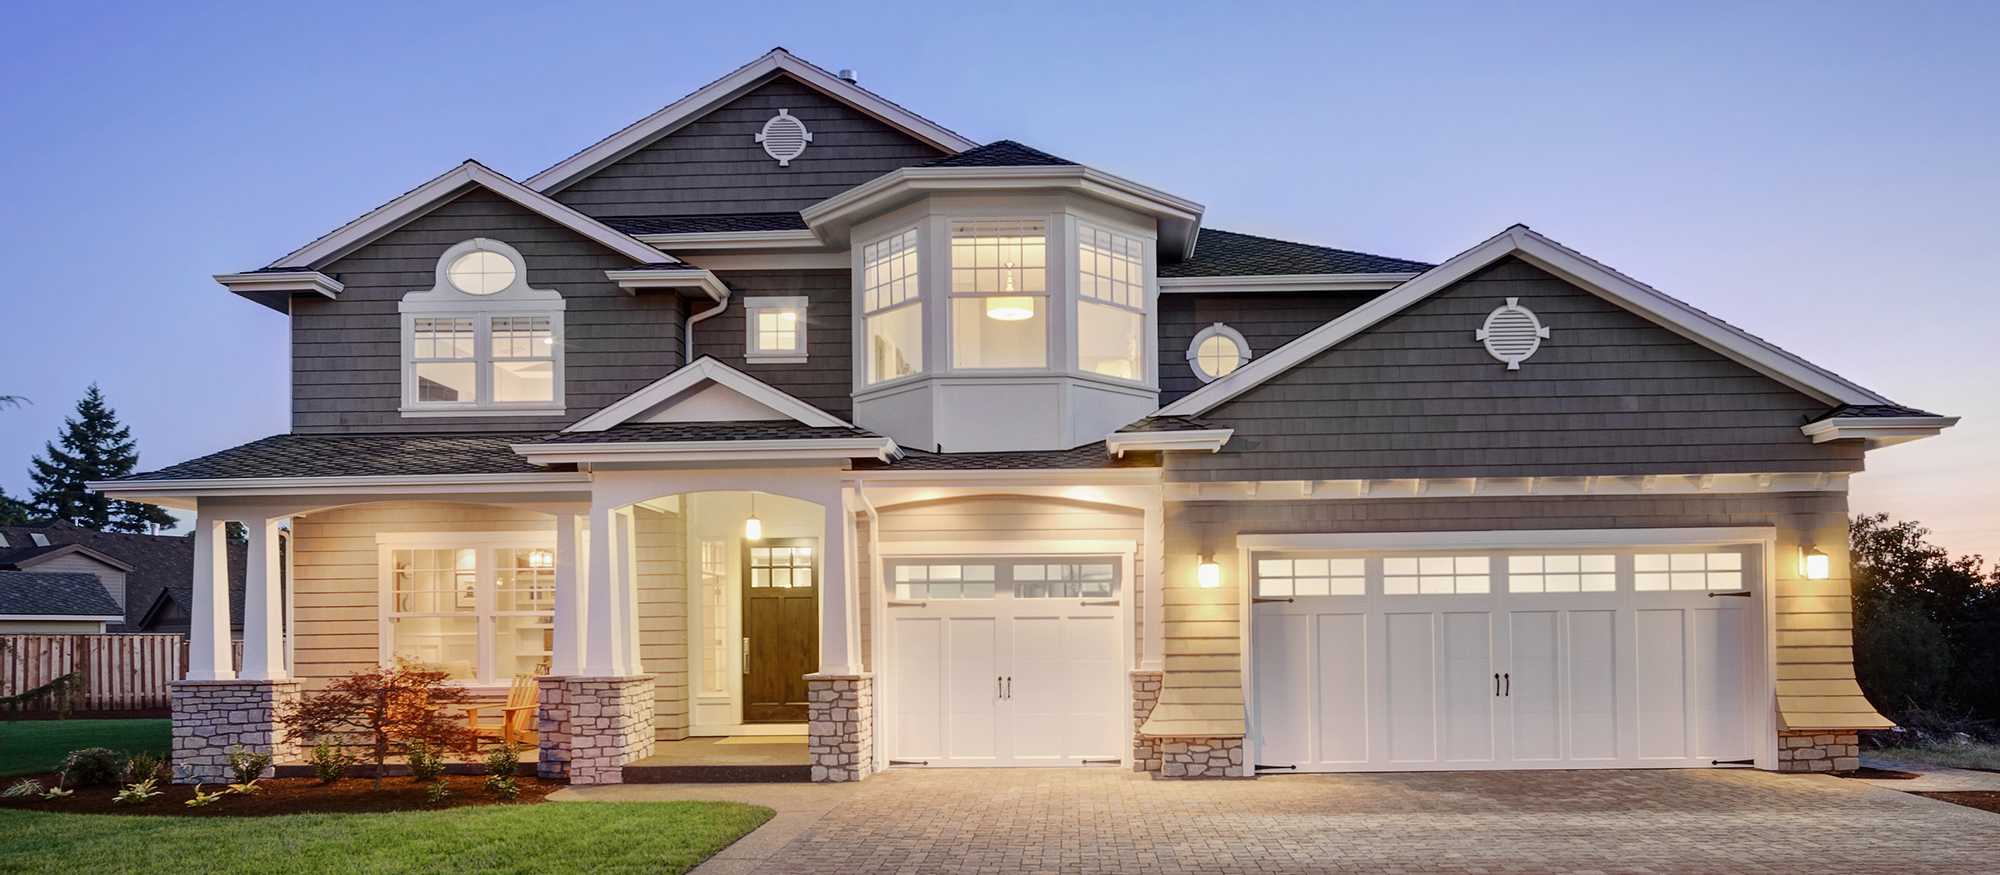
left=94, top=50, right=1954, bottom=783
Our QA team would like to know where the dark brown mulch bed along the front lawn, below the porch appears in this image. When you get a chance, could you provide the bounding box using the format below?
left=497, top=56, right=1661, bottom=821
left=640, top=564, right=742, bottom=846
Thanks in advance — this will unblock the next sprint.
left=0, top=775, right=566, bottom=817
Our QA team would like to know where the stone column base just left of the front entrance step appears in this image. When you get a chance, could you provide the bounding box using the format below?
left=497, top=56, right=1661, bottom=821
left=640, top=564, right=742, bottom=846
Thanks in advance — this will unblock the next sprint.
left=534, top=675, right=654, bottom=783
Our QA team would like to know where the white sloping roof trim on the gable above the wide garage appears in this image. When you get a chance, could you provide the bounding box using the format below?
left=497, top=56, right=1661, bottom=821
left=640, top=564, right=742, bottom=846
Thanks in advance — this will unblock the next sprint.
left=1160, top=226, right=1890, bottom=416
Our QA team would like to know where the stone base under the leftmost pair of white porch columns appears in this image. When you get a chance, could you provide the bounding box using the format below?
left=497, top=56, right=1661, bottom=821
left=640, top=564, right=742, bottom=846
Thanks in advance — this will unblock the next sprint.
left=168, top=681, right=302, bottom=783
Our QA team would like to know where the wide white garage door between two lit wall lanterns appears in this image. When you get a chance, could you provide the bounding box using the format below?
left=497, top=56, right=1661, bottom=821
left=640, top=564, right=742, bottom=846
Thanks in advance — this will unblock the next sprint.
left=1250, top=545, right=1762, bottom=771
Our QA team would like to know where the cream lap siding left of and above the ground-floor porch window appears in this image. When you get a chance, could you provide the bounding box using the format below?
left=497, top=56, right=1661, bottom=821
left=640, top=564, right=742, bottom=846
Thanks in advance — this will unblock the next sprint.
left=290, top=501, right=554, bottom=689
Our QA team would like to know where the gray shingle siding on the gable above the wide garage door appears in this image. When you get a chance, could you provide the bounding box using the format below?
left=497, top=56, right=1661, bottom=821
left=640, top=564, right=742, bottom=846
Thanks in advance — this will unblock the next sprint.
left=1168, top=260, right=1862, bottom=481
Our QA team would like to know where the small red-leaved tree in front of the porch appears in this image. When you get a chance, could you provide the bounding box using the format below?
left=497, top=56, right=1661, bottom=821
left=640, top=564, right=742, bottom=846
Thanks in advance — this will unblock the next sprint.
left=278, top=659, right=476, bottom=789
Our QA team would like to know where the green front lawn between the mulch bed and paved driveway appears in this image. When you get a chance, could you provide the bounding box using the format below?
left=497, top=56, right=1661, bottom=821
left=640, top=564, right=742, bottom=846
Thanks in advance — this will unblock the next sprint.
left=0, top=801, right=772, bottom=875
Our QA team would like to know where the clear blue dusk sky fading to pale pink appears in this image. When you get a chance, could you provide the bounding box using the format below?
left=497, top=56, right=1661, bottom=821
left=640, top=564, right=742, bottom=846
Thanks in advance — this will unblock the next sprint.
left=0, top=0, right=2000, bottom=557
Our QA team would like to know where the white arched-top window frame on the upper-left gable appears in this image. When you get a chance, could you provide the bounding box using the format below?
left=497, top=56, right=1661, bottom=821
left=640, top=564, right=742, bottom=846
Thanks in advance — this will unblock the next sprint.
left=400, top=238, right=568, bottom=420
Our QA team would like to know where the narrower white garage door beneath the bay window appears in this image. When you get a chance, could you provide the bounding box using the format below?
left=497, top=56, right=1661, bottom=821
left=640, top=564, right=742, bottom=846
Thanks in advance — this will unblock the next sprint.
left=886, top=557, right=1130, bottom=765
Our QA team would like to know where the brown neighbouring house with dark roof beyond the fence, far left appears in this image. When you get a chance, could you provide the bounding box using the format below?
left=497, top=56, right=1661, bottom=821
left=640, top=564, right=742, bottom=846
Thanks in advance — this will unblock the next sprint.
left=0, top=521, right=244, bottom=637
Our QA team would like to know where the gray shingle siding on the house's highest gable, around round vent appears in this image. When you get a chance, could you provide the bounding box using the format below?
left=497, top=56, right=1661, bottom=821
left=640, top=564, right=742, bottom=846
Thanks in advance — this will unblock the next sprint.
left=556, top=76, right=944, bottom=218
